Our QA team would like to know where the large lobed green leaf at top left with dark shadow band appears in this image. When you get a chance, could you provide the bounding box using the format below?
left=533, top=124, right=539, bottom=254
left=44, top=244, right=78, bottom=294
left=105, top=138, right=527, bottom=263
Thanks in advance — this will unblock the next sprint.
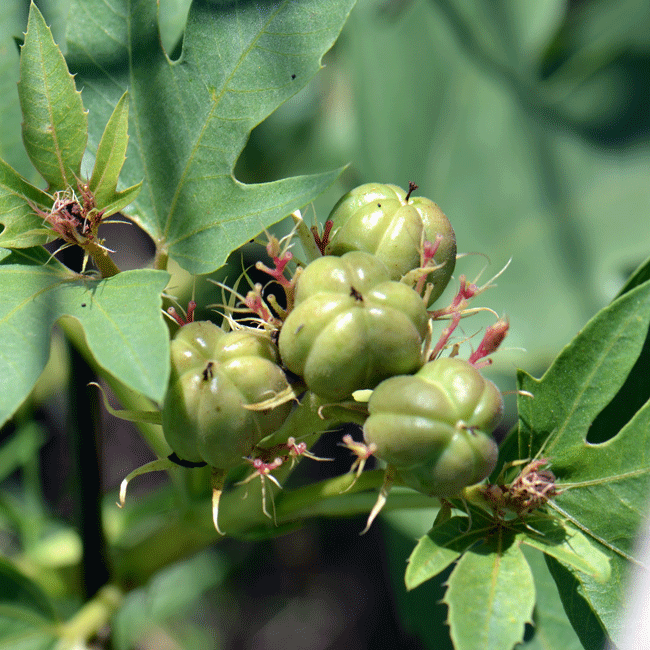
left=68, top=0, right=354, bottom=273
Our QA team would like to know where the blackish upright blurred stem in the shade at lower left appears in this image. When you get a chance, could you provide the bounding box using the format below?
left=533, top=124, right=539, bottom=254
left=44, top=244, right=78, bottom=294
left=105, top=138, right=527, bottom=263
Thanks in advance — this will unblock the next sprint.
left=67, top=348, right=109, bottom=599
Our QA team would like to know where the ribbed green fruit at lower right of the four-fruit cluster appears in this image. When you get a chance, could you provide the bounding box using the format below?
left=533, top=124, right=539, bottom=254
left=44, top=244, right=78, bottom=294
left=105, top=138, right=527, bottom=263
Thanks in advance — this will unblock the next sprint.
left=363, top=358, right=503, bottom=497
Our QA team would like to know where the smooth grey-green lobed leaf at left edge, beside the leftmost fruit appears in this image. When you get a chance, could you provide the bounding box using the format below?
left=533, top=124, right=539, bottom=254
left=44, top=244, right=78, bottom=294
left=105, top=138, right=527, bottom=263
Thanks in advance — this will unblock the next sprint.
left=0, top=249, right=169, bottom=424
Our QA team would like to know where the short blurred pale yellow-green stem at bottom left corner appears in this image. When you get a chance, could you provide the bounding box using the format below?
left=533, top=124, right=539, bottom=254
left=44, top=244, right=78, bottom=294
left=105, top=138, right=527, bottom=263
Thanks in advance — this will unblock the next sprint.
left=56, top=585, right=123, bottom=650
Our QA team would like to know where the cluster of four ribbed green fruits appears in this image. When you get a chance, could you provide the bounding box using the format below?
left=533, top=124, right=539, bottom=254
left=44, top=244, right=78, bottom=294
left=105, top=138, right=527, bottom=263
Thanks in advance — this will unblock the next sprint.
left=163, top=184, right=502, bottom=525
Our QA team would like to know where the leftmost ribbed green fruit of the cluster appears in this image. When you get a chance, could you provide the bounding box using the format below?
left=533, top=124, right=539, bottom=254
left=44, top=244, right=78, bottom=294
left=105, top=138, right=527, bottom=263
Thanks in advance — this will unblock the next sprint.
left=163, top=321, right=291, bottom=469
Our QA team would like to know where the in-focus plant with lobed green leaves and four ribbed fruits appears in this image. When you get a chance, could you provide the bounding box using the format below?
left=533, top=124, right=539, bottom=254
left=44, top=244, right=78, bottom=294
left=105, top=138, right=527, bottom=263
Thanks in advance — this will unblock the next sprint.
left=5, top=5, right=650, bottom=650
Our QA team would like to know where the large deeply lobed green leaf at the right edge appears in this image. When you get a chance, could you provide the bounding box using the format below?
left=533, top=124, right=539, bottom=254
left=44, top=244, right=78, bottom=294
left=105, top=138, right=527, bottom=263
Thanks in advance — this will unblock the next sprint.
left=519, top=282, right=650, bottom=642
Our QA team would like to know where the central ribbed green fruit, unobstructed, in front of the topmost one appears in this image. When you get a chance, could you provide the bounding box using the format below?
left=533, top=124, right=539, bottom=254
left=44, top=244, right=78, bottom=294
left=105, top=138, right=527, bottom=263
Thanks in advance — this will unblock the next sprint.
left=279, top=251, right=428, bottom=401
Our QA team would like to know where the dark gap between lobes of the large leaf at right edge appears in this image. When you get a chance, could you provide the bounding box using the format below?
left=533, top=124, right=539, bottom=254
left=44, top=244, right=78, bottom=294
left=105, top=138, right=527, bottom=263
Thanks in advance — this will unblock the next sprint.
left=587, top=322, right=650, bottom=445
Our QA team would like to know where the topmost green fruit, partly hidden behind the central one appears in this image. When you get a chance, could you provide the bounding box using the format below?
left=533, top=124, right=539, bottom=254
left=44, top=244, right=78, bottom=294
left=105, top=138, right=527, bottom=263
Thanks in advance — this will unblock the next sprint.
left=326, top=178, right=456, bottom=301
